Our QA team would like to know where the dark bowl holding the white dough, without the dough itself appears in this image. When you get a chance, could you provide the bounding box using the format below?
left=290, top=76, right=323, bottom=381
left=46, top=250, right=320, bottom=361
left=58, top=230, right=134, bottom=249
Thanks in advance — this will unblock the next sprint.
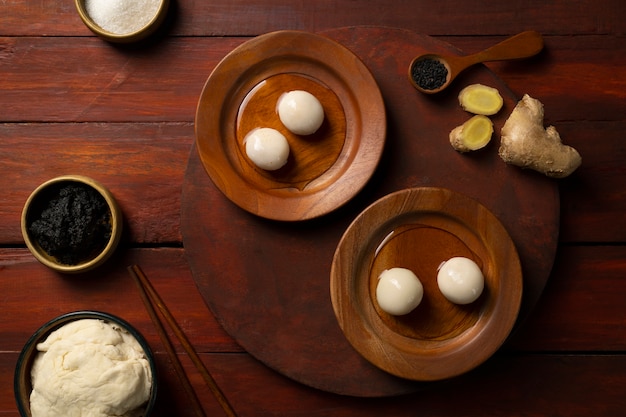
left=13, top=311, right=157, bottom=417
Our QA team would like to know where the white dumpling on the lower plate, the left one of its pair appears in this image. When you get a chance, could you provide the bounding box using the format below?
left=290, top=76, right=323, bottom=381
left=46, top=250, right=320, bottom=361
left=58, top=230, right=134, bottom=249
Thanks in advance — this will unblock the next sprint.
left=376, top=268, right=424, bottom=316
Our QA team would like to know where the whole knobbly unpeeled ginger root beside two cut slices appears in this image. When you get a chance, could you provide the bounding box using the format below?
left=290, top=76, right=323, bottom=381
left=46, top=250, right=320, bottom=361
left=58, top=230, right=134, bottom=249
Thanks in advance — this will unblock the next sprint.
left=498, top=94, right=582, bottom=178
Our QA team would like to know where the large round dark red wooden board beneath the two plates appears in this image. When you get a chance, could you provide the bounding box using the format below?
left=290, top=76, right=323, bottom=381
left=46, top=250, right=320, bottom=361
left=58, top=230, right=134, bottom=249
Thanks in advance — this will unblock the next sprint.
left=181, top=27, right=559, bottom=397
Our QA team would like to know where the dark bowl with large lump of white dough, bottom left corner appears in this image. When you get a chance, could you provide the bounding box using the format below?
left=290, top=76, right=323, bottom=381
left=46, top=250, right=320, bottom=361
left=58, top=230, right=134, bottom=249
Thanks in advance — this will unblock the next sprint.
left=14, top=311, right=157, bottom=417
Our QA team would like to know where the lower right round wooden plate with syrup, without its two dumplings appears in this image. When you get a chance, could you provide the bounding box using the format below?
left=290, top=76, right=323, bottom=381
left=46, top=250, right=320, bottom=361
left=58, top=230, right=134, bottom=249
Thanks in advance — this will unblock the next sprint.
left=330, top=187, right=522, bottom=381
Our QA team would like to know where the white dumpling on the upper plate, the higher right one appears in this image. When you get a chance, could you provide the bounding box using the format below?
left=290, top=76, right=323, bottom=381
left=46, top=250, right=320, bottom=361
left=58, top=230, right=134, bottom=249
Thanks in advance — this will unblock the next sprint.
left=278, top=90, right=324, bottom=136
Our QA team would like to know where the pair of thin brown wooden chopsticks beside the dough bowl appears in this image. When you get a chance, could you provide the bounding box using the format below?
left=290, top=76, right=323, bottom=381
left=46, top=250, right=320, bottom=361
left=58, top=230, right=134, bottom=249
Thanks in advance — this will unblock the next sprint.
left=128, top=265, right=236, bottom=417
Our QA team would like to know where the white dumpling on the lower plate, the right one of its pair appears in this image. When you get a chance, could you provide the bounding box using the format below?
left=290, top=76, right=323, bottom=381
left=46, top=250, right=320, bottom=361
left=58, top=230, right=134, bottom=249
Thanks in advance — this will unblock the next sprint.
left=437, top=257, right=485, bottom=304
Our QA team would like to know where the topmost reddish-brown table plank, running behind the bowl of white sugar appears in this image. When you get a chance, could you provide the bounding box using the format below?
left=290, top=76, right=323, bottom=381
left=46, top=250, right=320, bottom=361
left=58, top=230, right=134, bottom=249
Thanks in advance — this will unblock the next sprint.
left=0, top=0, right=625, bottom=36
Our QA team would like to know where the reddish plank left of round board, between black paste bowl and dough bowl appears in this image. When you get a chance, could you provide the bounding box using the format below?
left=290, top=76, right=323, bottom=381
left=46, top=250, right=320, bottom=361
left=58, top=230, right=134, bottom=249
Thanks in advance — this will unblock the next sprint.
left=0, top=248, right=240, bottom=354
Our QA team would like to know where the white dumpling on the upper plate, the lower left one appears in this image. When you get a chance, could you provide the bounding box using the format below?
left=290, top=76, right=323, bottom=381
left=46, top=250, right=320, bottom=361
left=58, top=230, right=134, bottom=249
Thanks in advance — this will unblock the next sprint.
left=244, top=127, right=289, bottom=171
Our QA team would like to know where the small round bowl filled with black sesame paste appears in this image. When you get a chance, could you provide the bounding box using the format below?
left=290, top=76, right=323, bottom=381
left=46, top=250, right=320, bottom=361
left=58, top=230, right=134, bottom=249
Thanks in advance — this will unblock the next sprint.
left=21, top=175, right=123, bottom=274
